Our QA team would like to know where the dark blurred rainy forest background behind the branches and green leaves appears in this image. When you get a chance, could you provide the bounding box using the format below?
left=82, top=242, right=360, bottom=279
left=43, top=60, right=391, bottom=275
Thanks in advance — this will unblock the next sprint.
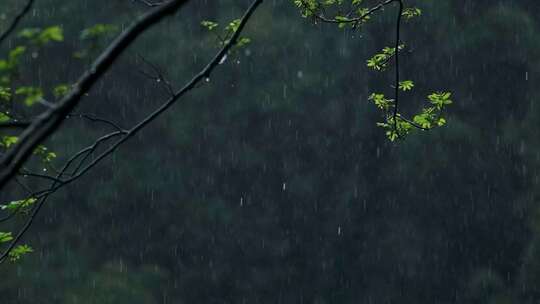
left=0, top=0, right=540, bottom=304
